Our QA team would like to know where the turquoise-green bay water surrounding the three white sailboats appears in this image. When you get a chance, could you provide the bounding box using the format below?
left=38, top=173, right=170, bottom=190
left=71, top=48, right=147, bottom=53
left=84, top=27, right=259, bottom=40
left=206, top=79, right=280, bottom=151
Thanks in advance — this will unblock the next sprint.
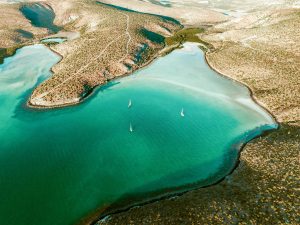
left=0, top=44, right=276, bottom=225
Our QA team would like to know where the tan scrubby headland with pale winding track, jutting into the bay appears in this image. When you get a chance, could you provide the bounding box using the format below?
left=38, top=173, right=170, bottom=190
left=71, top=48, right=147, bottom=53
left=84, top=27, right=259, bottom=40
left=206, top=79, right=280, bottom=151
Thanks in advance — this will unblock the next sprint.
left=29, top=1, right=180, bottom=107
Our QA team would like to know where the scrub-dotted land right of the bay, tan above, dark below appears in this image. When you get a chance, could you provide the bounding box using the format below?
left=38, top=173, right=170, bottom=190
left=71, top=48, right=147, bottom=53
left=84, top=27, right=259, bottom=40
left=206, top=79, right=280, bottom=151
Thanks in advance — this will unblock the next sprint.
left=98, top=7, right=300, bottom=224
